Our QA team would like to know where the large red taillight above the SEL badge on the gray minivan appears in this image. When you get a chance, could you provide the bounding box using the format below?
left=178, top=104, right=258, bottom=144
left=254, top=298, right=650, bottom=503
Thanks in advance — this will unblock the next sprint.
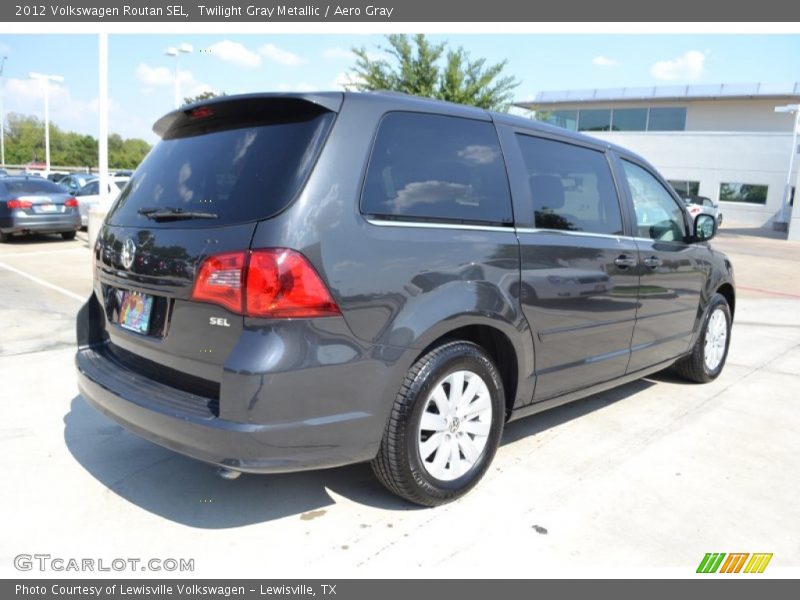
left=192, top=248, right=341, bottom=318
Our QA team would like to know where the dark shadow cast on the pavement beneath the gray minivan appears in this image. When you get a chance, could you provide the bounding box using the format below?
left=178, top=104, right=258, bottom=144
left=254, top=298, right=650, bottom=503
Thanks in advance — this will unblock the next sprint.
left=64, top=380, right=655, bottom=529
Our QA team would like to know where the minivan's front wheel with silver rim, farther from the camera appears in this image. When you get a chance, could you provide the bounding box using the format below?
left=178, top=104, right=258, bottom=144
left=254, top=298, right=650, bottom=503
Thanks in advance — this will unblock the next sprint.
left=674, top=294, right=732, bottom=383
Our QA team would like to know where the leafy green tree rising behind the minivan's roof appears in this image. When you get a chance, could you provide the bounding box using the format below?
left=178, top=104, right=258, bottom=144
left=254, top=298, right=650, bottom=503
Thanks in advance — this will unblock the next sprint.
left=348, top=34, right=519, bottom=111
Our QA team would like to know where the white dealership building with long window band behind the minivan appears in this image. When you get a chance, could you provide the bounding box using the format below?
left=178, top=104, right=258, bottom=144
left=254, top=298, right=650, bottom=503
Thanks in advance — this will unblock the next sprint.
left=516, top=83, right=800, bottom=239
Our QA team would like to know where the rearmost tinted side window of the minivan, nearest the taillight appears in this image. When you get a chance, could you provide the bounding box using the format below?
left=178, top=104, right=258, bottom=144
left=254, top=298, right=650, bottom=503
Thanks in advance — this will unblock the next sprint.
left=361, top=112, right=513, bottom=224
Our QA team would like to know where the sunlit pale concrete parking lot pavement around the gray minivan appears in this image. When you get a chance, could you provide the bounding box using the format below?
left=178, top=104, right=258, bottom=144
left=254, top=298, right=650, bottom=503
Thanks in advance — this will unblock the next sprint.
left=0, top=230, right=800, bottom=578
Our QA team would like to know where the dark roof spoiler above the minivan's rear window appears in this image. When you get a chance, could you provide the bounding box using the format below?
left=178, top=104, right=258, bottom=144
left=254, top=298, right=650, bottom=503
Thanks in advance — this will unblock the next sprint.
left=153, top=92, right=344, bottom=139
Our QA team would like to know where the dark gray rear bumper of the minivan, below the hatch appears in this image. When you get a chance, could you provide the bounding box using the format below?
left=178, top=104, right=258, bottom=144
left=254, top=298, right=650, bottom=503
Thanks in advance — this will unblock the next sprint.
left=75, top=348, right=382, bottom=473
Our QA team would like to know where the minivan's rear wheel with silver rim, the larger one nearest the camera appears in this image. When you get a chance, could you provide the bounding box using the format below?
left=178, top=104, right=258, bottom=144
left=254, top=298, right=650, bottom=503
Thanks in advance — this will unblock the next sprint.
left=372, top=341, right=505, bottom=506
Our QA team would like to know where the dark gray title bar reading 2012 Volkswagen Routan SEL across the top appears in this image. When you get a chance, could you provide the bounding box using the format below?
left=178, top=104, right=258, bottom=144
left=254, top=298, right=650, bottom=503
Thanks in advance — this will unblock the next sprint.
left=0, top=0, right=800, bottom=23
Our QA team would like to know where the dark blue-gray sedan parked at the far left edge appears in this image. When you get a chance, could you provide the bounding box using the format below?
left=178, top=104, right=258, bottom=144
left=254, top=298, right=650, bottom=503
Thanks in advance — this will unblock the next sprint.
left=0, top=177, right=81, bottom=242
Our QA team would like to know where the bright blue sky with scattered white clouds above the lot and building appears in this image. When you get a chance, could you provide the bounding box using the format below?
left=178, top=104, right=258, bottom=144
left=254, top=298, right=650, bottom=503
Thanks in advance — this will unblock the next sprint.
left=0, top=34, right=800, bottom=141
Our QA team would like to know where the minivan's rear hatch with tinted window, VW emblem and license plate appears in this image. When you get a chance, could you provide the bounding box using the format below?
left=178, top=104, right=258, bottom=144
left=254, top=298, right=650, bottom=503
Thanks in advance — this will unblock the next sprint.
left=95, top=94, right=341, bottom=399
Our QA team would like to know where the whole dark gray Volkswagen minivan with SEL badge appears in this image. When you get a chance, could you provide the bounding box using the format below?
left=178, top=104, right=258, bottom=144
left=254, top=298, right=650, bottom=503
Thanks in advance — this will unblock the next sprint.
left=76, top=93, right=735, bottom=505
